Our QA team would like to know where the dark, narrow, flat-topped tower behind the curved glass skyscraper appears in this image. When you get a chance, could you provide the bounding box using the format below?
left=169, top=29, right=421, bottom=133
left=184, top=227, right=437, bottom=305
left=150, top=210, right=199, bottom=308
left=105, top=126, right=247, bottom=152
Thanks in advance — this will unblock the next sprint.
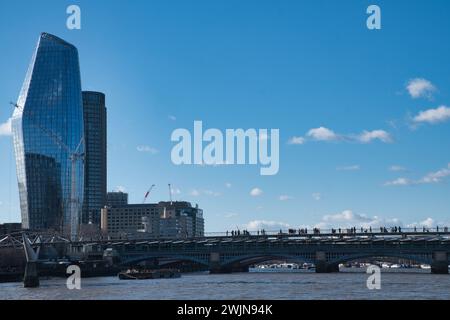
left=82, top=91, right=107, bottom=227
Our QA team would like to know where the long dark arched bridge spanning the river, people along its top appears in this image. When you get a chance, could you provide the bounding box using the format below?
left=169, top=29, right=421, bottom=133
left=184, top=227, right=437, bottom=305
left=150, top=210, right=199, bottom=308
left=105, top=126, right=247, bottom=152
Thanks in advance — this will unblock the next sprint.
left=0, top=229, right=450, bottom=274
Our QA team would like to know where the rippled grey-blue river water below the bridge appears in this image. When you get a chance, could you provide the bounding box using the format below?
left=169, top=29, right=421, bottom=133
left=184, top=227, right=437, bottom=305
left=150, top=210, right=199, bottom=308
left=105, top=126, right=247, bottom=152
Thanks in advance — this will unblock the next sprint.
left=0, top=269, right=450, bottom=300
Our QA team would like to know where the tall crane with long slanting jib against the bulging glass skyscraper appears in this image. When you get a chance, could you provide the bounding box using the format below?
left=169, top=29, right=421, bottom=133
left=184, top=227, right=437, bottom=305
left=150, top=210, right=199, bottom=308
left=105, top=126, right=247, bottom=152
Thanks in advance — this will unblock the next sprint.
left=10, top=102, right=85, bottom=241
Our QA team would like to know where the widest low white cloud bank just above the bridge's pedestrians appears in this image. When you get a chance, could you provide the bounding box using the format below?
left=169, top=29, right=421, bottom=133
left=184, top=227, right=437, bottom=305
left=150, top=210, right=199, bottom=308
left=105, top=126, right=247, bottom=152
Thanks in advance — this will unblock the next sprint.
left=315, top=210, right=403, bottom=229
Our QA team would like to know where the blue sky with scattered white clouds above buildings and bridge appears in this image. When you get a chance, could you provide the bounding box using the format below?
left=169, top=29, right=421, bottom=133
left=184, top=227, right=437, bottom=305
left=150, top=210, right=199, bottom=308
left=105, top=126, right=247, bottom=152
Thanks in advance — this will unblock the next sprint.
left=0, top=0, right=450, bottom=231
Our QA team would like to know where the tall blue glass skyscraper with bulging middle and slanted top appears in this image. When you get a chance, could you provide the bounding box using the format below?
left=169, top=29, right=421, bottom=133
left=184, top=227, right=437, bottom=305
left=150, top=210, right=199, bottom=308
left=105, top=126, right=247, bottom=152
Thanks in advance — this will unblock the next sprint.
left=12, top=33, right=84, bottom=234
